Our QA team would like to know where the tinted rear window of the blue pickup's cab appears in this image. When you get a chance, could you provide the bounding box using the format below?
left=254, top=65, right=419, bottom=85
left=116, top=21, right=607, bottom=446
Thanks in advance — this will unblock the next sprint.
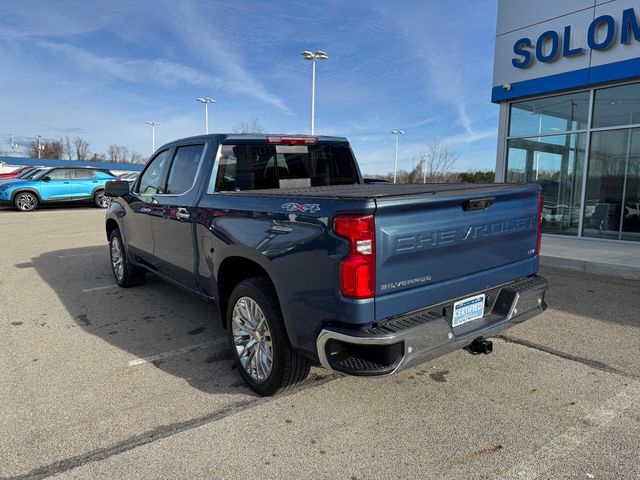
left=215, top=144, right=358, bottom=192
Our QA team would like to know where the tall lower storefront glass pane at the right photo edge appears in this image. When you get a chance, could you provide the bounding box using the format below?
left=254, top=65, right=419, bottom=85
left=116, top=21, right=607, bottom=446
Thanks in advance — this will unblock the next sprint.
left=583, top=129, right=640, bottom=241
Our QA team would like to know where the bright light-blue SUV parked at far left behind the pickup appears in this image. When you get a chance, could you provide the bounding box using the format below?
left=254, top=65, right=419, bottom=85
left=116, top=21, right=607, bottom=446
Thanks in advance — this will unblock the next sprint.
left=0, top=167, right=116, bottom=212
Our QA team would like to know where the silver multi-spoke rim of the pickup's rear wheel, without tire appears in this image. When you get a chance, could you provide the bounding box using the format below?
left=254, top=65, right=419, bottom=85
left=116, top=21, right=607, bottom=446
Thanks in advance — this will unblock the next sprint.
left=231, top=297, right=273, bottom=383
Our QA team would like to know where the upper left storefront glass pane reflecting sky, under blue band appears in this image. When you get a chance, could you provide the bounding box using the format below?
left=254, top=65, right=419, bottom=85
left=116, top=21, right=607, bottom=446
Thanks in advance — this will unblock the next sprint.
left=509, top=92, right=590, bottom=137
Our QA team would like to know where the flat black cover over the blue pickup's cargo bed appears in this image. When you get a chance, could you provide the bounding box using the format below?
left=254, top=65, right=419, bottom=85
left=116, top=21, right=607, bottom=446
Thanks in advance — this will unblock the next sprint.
left=220, top=183, right=529, bottom=200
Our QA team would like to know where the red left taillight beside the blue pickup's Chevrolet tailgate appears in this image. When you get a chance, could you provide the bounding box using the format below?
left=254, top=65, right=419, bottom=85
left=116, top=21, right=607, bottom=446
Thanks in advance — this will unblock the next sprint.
left=333, top=215, right=376, bottom=299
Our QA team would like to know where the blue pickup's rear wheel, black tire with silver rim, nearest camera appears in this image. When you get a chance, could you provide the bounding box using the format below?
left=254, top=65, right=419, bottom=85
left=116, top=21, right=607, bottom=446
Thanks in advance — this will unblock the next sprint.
left=227, top=277, right=311, bottom=396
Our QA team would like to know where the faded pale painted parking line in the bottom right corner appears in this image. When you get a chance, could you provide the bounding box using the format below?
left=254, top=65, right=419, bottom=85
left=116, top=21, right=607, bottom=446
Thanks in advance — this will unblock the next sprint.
left=506, top=382, right=640, bottom=480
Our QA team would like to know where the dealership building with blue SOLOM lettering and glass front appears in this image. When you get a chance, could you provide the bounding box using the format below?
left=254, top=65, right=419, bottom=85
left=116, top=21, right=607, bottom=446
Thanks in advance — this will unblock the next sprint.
left=492, top=0, right=640, bottom=242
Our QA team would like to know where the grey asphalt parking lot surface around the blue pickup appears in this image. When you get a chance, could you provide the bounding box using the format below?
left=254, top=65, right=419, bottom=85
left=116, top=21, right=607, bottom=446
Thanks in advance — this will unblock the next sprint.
left=0, top=208, right=640, bottom=480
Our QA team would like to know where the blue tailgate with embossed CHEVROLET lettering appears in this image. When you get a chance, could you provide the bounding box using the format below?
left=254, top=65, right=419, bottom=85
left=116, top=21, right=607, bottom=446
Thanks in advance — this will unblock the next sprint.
left=375, top=185, right=540, bottom=320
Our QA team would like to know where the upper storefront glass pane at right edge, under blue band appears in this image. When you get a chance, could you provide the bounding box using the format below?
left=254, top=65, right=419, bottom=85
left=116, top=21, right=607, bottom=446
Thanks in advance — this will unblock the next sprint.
left=592, top=83, right=640, bottom=128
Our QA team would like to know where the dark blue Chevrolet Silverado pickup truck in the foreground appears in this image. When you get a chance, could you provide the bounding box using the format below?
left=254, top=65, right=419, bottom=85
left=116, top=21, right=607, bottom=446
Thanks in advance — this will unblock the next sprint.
left=106, top=135, right=548, bottom=395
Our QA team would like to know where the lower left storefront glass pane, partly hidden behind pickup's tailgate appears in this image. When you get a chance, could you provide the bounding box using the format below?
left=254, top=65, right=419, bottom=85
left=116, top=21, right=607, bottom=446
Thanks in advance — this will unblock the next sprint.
left=507, top=133, right=586, bottom=235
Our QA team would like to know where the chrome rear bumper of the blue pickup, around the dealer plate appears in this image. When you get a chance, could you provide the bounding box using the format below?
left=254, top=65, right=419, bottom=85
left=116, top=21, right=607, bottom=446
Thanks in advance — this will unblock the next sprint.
left=316, top=275, right=549, bottom=376
